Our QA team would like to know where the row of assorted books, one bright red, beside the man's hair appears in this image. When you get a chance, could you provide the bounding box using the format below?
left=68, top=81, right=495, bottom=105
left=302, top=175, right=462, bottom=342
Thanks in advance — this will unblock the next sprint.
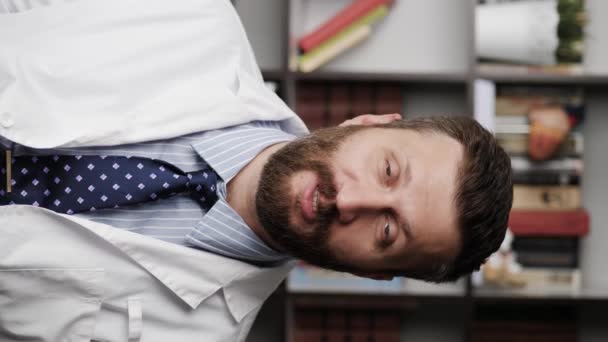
left=496, top=86, right=589, bottom=294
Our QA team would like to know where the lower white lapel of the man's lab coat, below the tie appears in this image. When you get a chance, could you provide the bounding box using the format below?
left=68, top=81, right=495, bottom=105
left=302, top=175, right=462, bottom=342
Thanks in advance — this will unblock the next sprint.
left=58, top=210, right=295, bottom=322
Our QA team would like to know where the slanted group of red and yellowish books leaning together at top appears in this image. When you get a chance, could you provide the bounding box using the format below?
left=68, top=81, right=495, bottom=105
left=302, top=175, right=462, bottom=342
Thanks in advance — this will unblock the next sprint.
left=298, top=0, right=393, bottom=72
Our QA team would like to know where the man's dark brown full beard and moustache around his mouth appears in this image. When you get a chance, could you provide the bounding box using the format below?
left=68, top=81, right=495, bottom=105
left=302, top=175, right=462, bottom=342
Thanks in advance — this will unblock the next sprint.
left=255, top=126, right=364, bottom=270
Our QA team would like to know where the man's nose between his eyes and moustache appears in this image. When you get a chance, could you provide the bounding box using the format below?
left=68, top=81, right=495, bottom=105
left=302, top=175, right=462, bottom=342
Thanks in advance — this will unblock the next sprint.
left=336, top=186, right=390, bottom=224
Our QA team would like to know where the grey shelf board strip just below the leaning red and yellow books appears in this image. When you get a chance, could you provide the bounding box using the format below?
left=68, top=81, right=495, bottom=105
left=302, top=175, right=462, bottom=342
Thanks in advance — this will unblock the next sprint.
left=293, top=71, right=468, bottom=85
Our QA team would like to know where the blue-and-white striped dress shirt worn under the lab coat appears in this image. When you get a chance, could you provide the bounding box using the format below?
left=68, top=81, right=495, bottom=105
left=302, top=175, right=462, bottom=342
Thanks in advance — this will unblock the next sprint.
left=0, top=121, right=295, bottom=265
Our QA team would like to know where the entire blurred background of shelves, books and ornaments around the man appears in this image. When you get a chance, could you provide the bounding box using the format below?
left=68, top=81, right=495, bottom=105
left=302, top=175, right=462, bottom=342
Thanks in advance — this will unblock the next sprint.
left=232, top=0, right=608, bottom=342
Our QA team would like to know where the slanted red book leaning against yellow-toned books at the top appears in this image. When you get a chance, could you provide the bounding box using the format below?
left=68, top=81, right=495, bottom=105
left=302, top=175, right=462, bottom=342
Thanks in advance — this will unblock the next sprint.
left=298, top=0, right=393, bottom=52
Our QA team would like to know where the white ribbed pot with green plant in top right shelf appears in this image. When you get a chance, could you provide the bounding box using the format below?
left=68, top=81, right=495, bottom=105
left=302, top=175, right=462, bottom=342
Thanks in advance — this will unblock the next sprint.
left=476, top=0, right=586, bottom=73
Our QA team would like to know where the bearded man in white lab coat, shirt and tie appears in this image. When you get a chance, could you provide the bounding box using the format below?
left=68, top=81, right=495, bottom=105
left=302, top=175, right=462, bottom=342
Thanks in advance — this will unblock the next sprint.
left=0, top=0, right=512, bottom=341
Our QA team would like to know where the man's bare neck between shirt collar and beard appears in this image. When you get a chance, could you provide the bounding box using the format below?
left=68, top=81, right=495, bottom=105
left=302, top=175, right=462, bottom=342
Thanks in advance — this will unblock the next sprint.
left=227, top=142, right=287, bottom=251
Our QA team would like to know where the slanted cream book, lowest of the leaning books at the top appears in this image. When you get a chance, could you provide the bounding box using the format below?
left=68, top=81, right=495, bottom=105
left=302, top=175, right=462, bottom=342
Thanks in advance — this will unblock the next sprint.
left=298, top=25, right=371, bottom=72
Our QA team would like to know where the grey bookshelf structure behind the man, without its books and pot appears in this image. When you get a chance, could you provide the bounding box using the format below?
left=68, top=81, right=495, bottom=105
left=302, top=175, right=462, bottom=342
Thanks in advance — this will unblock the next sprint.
left=233, top=0, right=608, bottom=342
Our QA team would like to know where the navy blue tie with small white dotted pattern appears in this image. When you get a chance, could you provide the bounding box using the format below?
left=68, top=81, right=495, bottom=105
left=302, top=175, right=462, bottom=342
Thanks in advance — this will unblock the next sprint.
left=0, top=155, right=218, bottom=214
